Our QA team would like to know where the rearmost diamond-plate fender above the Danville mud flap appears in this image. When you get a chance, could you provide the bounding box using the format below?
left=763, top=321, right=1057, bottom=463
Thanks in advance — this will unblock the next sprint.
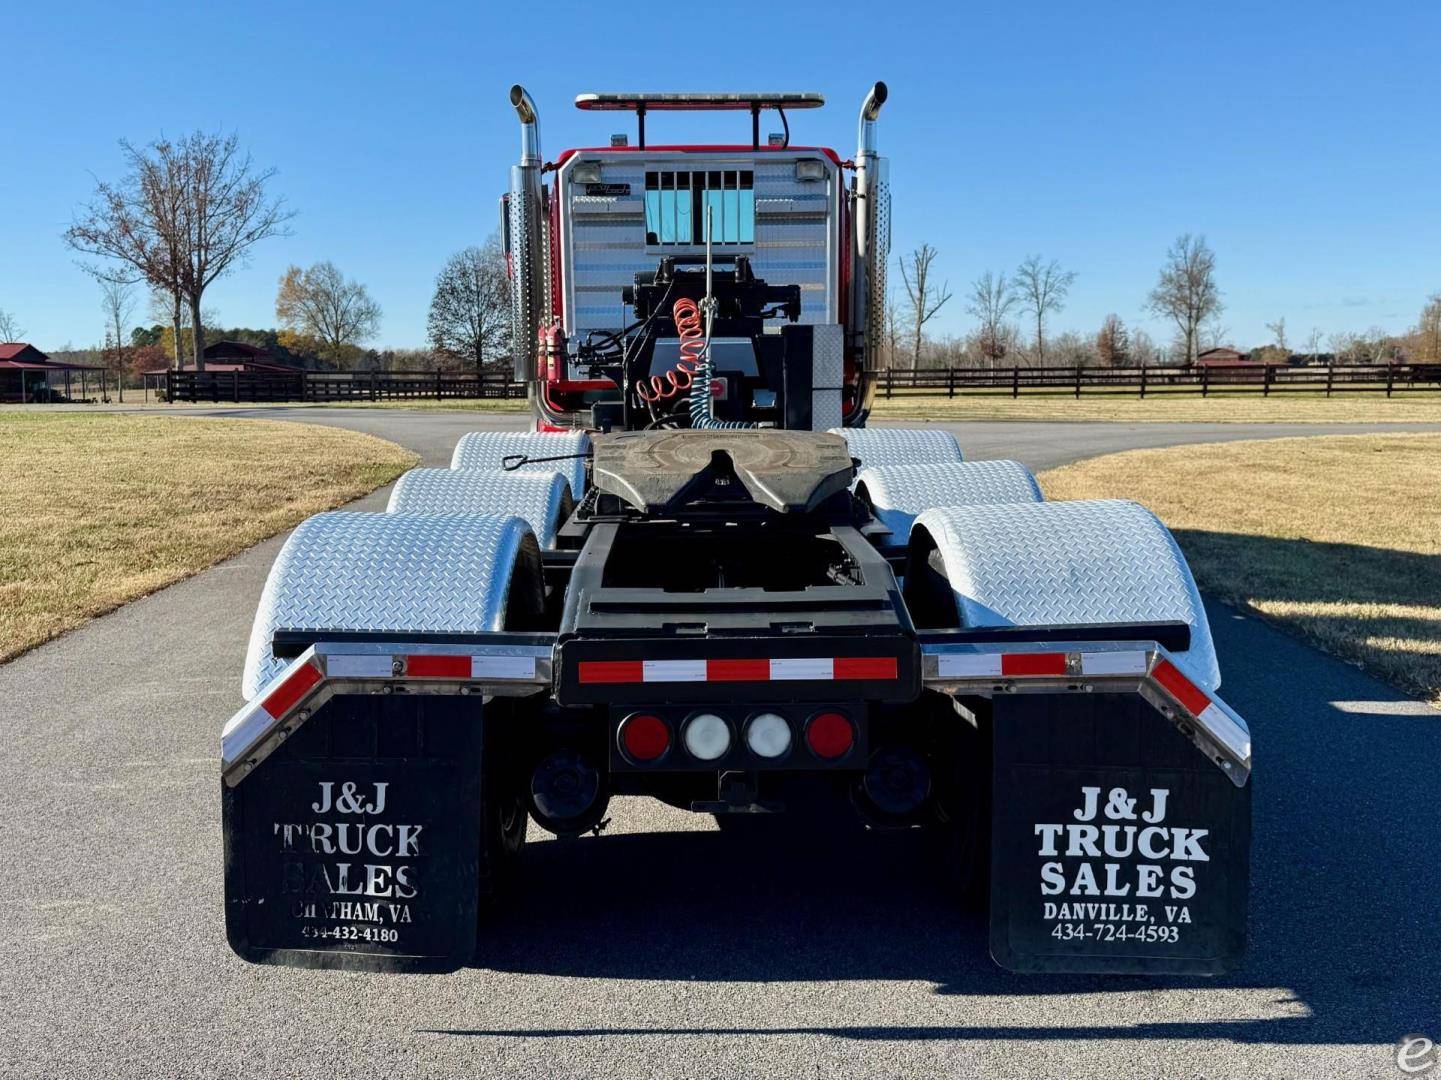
left=912, top=499, right=1221, bottom=691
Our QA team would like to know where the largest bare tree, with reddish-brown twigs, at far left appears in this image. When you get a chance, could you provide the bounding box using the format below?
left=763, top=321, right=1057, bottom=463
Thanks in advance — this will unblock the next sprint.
left=65, top=131, right=293, bottom=371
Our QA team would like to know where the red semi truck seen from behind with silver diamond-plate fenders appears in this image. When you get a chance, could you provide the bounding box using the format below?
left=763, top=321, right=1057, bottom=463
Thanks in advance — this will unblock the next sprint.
left=220, top=82, right=1251, bottom=973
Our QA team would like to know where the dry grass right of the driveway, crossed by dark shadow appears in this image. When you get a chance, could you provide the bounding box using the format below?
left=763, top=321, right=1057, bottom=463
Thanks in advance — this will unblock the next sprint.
left=1040, top=434, right=1441, bottom=704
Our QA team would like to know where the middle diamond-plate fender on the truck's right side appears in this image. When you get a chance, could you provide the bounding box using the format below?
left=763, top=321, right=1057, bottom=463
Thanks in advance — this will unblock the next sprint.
left=856, top=461, right=1043, bottom=541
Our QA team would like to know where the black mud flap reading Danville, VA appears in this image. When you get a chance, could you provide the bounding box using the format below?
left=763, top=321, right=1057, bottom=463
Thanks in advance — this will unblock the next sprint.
left=990, top=692, right=1251, bottom=975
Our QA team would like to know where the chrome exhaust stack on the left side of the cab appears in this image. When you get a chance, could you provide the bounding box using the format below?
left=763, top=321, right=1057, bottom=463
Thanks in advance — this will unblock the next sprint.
left=509, top=84, right=549, bottom=382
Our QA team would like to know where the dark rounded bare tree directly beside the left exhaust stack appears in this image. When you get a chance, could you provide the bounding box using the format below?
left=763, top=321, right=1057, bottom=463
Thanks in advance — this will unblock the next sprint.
left=425, top=236, right=510, bottom=375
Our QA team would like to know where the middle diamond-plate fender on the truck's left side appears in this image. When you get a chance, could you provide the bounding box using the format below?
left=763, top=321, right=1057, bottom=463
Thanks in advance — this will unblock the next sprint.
left=385, top=469, right=571, bottom=548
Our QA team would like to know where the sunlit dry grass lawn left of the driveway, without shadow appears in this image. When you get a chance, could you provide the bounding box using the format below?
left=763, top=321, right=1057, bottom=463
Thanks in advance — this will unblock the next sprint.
left=0, top=411, right=416, bottom=660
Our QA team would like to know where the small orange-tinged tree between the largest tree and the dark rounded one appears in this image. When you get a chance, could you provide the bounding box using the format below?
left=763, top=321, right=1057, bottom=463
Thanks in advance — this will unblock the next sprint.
left=275, top=261, right=380, bottom=366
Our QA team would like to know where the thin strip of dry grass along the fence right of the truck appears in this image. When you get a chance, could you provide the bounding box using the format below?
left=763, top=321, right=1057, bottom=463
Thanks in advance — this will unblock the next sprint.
left=872, top=392, right=1441, bottom=424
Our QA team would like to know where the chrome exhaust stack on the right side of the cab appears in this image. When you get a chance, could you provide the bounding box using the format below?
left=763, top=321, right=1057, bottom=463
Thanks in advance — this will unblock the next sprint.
left=852, top=82, right=891, bottom=386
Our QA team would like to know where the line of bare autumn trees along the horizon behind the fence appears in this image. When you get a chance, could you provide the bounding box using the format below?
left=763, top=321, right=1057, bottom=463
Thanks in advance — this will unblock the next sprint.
left=8, top=131, right=1441, bottom=375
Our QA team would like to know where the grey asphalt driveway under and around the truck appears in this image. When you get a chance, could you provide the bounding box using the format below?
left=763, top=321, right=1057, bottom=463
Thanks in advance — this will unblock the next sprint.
left=0, top=410, right=1441, bottom=1080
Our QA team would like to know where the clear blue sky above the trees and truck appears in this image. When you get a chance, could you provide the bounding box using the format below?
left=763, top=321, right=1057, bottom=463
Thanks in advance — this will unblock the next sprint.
left=0, top=0, right=1441, bottom=349
